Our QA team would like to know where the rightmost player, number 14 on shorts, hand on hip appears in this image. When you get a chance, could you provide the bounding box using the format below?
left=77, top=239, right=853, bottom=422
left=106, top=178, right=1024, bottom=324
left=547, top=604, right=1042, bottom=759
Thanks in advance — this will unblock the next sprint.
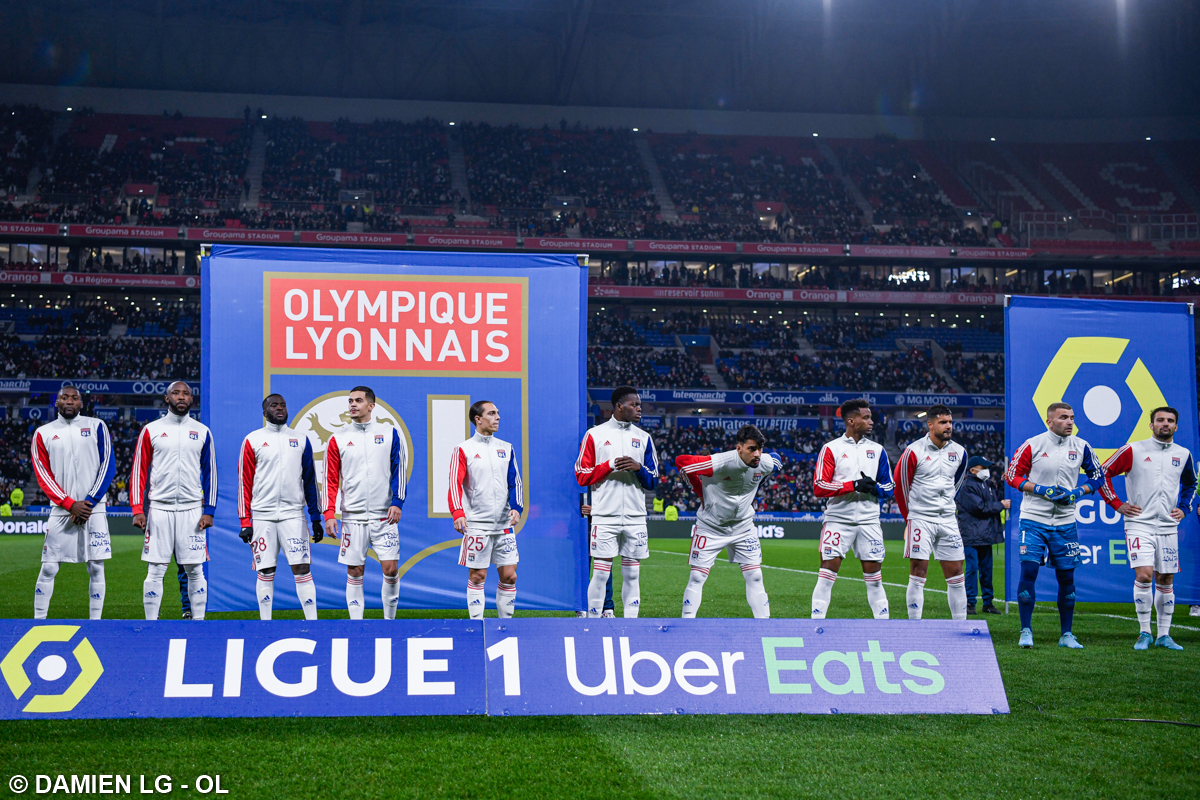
left=1100, top=405, right=1196, bottom=650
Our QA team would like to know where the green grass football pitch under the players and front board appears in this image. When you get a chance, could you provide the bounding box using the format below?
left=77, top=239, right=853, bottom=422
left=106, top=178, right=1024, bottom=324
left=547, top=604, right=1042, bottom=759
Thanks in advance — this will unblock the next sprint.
left=0, top=536, right=1200, bottom=800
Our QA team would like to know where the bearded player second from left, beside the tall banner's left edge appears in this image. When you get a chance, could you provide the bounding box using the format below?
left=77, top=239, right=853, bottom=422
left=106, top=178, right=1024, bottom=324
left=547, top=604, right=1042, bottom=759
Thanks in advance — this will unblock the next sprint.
left=130, top=380, right=217, bottom=619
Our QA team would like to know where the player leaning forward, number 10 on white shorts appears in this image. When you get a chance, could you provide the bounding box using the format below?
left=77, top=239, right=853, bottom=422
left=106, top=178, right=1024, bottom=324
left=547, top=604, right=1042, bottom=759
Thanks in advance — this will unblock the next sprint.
left=676, top=425, right=780, bottom=619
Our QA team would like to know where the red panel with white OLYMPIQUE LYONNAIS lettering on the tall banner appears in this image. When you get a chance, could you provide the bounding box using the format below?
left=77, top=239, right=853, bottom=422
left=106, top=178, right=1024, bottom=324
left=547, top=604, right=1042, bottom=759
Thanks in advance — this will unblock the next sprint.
left=268, top=276, right=524, bottom=374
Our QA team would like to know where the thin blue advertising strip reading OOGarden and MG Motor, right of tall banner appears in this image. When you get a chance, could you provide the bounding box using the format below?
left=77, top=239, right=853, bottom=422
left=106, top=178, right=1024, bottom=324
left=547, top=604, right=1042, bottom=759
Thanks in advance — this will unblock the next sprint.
left=597, top=386, right=1004, bottom=408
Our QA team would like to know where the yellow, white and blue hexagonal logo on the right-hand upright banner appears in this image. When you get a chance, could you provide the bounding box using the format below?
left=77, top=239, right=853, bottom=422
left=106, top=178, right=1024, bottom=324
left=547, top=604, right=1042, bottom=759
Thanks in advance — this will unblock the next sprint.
left=1033, top=336, right=1168, bottom=461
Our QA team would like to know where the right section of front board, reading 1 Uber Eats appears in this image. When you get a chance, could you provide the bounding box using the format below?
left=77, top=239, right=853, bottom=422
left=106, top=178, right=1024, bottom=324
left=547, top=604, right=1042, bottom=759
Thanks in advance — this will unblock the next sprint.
left=484, top=619, right=1008, bottom=716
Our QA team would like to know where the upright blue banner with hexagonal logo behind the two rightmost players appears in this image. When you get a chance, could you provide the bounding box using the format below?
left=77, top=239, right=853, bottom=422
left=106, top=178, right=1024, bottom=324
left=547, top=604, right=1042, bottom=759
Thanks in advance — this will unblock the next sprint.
left=1004, top=297, right=1200, bottom=604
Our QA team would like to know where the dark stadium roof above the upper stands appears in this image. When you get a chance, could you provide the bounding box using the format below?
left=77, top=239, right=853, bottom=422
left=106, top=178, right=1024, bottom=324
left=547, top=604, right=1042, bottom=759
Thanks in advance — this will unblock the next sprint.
left=0, top=0, right=1200, bottom=119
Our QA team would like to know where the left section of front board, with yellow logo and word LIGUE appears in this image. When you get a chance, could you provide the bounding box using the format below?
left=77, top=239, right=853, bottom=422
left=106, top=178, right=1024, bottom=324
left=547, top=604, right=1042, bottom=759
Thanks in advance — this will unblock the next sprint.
left=0, top=620, right=486, bottom=720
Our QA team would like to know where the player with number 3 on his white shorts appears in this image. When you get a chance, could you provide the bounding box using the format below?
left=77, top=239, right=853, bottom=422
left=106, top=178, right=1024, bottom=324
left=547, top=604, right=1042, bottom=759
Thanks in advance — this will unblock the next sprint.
left=894, top=405, right=967, bottom=619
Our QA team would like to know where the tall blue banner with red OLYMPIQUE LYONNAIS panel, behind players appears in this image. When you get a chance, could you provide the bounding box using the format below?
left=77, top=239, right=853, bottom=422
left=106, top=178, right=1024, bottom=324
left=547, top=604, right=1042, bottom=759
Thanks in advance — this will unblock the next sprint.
left=202, top=245, right=588, bottom=610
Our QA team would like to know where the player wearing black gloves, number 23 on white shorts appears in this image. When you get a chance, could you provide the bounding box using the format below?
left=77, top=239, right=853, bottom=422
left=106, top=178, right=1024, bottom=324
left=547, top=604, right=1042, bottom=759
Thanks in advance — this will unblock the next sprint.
left=812, top=398, right=894, bottom=619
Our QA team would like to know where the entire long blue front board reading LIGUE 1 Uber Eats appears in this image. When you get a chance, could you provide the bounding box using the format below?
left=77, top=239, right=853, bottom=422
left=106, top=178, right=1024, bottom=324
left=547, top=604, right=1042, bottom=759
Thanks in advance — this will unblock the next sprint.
left=0, top=618, right=1009, bottom=720
